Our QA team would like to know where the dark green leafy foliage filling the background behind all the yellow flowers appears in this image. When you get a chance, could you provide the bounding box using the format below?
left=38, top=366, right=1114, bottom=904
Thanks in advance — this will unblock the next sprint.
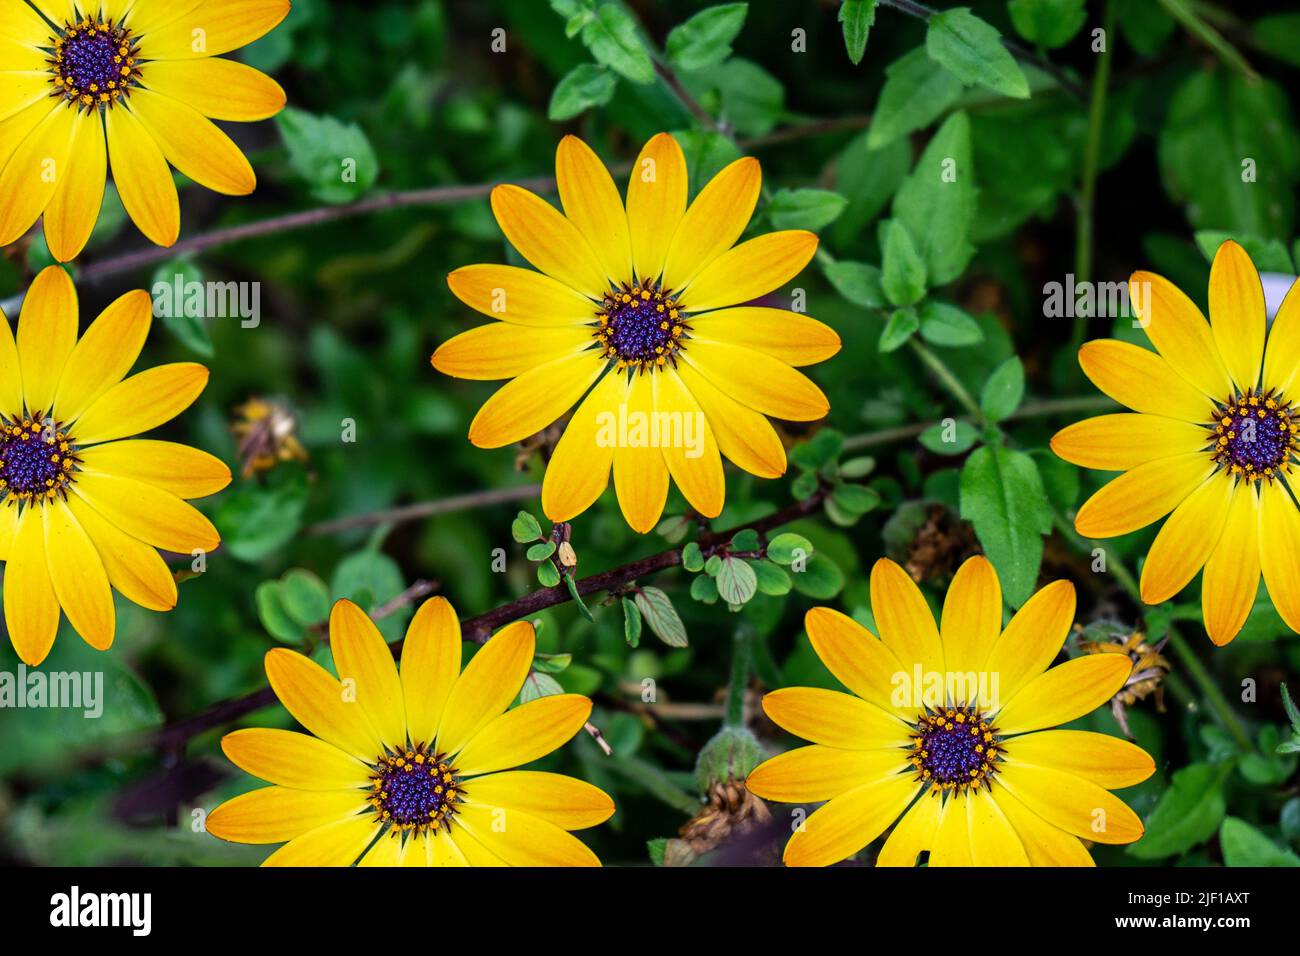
left=0, top=0, right=1300, bottom=866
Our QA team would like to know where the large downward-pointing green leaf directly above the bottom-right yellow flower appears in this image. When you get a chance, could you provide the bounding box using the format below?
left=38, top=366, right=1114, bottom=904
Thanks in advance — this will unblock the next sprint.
left=961, top=445, right=1052, bottom=607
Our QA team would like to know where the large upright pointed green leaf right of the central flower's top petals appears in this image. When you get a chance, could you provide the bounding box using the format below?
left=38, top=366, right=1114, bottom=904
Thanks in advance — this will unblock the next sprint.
left=893, top=113, right=975, bottom=283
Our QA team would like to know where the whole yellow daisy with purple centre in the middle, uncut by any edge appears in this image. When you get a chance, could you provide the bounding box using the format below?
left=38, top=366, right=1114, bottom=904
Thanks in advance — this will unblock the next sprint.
left=433, top=133, right=840, bottom=532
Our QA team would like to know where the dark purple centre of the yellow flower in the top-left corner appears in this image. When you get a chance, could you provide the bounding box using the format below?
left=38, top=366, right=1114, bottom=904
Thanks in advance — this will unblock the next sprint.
left=49, top=20, right=139, bottom=108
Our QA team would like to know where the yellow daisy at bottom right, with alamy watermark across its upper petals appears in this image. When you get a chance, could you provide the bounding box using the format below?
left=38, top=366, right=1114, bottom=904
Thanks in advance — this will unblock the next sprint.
left=749, top=557, right=1154, bottom=866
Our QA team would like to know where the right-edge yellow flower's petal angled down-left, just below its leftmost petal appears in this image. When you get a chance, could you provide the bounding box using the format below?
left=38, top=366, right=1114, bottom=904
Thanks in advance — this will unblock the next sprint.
left=1074, top=451, right=1214, bottom=538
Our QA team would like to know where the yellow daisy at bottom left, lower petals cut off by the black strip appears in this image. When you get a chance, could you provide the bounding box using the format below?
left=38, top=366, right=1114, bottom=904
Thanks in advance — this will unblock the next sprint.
left=207, top=597, right=614, bottom=866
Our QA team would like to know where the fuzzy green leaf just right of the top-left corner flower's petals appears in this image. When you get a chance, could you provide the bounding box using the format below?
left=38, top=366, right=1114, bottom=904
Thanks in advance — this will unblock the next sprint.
left=276, top=107, right=380, bottom=203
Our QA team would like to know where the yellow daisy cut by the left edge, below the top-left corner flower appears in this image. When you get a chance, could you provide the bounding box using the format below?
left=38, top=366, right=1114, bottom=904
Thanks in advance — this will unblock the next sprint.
left=0, top=265, right=230, bottom=666
